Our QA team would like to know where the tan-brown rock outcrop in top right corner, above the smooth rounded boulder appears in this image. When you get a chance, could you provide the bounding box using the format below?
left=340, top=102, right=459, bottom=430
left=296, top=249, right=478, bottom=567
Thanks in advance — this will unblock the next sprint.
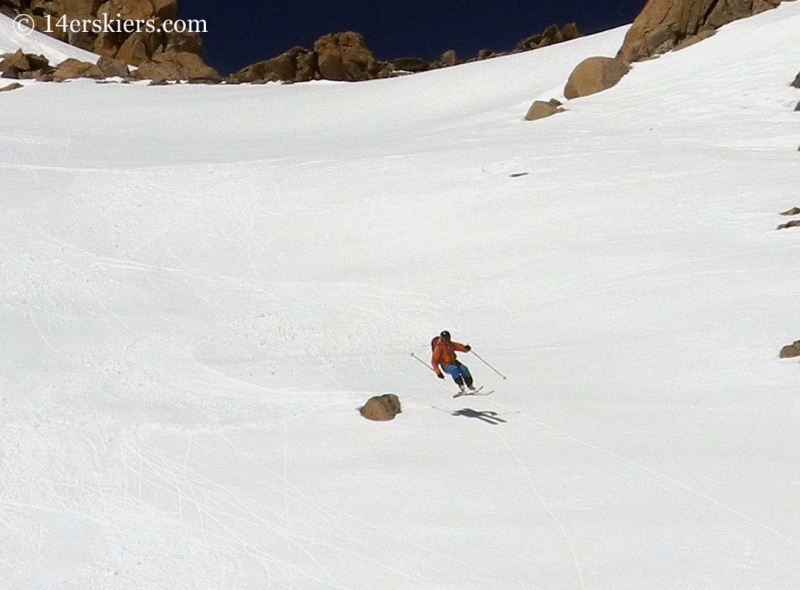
left=617, top=0, right=781, bottom=63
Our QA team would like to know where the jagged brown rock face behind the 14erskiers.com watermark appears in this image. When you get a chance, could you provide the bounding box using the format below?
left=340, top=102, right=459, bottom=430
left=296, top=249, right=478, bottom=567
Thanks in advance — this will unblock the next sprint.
left=0, top=0, right=221, bottom=80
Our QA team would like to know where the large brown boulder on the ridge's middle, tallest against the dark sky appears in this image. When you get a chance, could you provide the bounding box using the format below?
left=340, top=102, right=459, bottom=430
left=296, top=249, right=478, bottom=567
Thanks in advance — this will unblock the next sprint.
left=314, top=31, right=380, bottom=82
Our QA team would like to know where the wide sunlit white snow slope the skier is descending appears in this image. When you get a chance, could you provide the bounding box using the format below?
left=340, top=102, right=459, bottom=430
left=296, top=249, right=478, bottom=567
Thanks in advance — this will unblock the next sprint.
left=0, top=3, right=800, bottom=590
